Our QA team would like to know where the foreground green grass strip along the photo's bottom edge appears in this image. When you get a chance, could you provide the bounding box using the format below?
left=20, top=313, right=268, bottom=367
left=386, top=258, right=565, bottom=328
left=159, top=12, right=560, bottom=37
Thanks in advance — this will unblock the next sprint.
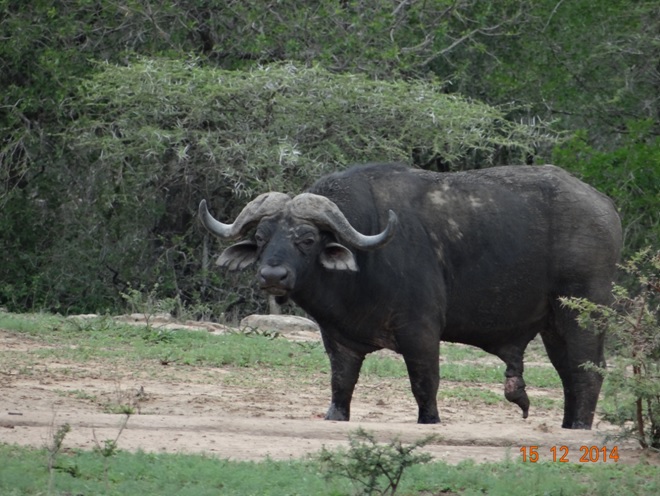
left=0, top=444, right=660, bottom=496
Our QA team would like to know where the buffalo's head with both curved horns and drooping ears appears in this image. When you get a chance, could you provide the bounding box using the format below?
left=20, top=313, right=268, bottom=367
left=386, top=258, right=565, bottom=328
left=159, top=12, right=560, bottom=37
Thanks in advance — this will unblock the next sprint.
left=199, top=192, right=398, bottom=297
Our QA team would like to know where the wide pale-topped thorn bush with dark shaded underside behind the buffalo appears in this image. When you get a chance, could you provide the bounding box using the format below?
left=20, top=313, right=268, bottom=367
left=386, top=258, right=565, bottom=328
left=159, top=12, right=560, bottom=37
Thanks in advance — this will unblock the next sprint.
left=0, top=57, right=551, bottom=319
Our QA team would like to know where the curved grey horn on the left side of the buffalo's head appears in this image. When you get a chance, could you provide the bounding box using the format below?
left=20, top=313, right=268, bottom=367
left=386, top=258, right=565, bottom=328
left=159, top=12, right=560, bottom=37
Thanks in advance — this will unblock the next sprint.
left=199, top=192, right=291, bottom=239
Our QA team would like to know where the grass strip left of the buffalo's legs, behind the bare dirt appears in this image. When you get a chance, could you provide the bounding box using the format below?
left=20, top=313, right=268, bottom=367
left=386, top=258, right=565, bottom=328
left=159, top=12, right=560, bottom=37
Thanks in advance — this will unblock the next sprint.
left=0, top=314, right=329, bottom=374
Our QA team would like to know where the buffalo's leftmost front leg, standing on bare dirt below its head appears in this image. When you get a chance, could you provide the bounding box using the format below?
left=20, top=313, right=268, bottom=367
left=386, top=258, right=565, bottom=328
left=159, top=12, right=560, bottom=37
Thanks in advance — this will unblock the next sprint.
left=323, top=337, right=365, bottom=421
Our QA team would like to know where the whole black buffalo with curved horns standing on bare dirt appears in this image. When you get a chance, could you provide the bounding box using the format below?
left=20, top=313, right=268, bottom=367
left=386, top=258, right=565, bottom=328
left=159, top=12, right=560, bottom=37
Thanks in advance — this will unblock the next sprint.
left=199, top=164, right=621, bottom=429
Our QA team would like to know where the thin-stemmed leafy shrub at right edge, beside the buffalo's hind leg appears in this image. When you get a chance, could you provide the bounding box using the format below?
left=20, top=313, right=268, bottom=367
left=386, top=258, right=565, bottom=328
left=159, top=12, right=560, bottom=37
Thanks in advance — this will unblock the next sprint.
left=562, top=249, right=660, bottom=450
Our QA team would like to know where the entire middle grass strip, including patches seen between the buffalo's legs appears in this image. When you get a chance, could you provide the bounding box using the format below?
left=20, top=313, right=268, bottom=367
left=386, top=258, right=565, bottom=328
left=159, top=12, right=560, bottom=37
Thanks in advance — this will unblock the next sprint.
left=0, top=312, right=561, bottom=388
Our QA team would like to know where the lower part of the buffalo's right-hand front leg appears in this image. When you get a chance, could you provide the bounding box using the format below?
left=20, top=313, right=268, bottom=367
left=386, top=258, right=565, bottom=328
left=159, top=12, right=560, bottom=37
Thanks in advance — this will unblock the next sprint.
left=403, top=353, right=440, bottom=424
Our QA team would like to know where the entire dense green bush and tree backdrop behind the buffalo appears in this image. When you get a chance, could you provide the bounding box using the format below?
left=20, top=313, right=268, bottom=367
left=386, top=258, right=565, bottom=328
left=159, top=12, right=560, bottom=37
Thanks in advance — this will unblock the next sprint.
left=0, top=0, right=660, bottom=318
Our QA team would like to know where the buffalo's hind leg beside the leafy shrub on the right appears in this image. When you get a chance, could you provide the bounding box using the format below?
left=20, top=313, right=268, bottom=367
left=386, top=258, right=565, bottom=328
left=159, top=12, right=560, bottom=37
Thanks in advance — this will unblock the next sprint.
left=541, top=296, right=605, bottom=429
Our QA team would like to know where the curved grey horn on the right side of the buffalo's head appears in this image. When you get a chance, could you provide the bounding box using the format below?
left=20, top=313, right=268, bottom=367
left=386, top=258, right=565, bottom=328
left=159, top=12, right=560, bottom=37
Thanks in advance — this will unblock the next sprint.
left=288, top=193, right=399, bottom=250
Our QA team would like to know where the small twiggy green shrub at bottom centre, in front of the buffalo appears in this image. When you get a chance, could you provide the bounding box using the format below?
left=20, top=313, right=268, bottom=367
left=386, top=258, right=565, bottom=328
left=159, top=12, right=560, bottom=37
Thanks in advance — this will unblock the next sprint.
left=318, top=428, right=437, bottom=495
